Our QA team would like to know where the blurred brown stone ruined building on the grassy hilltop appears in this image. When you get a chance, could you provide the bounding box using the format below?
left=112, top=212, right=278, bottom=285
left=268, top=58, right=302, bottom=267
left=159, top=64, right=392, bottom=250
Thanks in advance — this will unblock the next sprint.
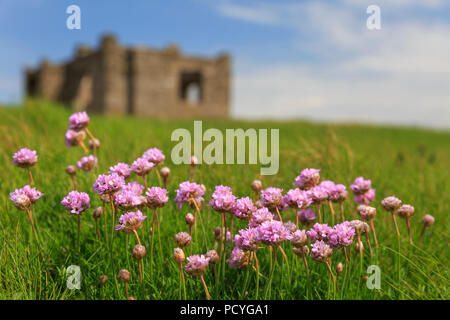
left=25, top=35, right=231, bottom=117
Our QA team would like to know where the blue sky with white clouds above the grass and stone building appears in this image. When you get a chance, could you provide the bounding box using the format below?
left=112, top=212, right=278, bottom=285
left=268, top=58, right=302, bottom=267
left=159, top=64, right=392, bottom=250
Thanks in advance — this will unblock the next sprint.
left=0, top=0, right=450, bottom=128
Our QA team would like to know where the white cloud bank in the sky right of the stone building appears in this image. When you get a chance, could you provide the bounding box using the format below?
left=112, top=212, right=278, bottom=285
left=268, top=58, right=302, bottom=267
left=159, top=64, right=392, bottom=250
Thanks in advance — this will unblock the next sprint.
left=214, top=0, right=450, bottom=128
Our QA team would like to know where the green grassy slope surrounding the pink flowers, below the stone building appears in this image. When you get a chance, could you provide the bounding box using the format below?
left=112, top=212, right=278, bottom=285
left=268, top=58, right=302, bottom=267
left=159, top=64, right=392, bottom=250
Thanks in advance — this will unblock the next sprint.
left=0, top=100, right=450, bottom=299
